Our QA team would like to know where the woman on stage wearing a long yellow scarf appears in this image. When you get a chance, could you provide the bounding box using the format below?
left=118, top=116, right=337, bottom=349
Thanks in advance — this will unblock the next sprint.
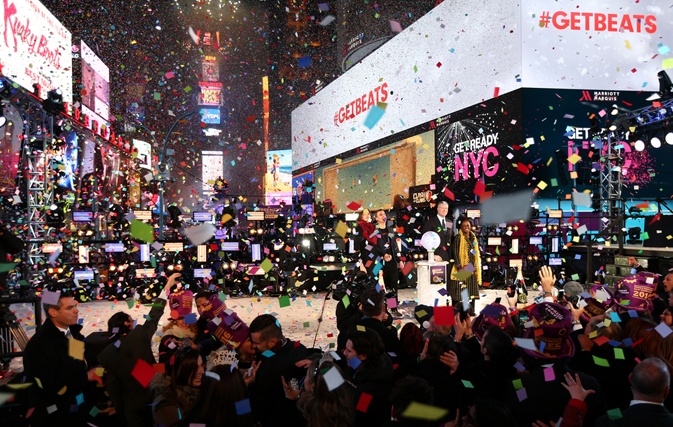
left=451, top=217, right=481, bottom=304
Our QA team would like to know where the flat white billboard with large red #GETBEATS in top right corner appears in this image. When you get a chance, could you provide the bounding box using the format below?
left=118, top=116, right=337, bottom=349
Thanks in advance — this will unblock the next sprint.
left=521, top=0, right=673, bottom=91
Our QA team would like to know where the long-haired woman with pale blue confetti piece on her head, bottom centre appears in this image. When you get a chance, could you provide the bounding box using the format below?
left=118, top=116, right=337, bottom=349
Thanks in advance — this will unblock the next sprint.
left=286, top=356, right=355, bottom=427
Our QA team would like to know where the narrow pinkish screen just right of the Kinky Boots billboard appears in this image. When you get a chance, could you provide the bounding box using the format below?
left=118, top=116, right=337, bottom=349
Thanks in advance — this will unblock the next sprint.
left=81, top=41, right=110, bottom=121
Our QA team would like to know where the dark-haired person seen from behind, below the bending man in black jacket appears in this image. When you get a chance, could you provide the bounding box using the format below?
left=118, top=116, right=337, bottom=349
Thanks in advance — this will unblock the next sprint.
left=180, top=365, right=254, bottom=427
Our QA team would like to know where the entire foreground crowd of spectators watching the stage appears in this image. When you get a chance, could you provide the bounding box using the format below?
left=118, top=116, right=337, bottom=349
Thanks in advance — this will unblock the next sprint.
left=9, top=252, right=673, bottom=427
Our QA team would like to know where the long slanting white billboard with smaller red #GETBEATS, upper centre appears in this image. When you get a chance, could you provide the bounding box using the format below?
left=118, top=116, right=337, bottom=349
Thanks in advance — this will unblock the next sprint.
left=292, top=0, right=521, bottom=171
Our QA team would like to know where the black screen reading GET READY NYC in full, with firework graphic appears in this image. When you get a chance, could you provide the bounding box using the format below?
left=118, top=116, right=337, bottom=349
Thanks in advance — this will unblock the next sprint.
left=436, top=90, right=530, bottom=201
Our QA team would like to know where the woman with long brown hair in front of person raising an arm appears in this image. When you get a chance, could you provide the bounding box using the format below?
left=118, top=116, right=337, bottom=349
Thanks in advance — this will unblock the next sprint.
left=149, top=347, right=204, bottom=427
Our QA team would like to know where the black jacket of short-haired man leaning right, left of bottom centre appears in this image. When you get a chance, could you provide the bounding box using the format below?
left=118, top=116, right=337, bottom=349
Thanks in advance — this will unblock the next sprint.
left=250, top=340, right=309, bottom=427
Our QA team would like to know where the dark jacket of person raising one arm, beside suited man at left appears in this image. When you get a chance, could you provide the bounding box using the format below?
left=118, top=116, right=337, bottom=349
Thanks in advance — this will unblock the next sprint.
left=98, top=299, right=166, bottom=427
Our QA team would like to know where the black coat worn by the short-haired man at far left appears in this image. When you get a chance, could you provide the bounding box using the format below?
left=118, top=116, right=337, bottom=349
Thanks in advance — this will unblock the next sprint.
left=23, top=318, right=91, bottom=426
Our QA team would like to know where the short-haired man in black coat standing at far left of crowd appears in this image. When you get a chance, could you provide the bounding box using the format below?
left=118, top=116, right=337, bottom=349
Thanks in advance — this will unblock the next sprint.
left=23, top=292, right=95, bottom=426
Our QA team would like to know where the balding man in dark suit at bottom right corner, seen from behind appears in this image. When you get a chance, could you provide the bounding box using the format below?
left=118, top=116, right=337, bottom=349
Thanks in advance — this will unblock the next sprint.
left=596, top=357, right=673, bottom=427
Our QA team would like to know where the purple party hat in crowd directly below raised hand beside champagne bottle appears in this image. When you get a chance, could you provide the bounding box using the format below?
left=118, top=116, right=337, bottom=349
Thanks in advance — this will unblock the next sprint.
left=522, top=302, right=575, bottom=360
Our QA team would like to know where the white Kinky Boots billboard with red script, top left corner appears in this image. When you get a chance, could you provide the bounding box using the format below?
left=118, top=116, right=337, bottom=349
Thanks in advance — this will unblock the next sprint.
left=0, top=0, right=72, bottom=103
